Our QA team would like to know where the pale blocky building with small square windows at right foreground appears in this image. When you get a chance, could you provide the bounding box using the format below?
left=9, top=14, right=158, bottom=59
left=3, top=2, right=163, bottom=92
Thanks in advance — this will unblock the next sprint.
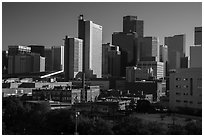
left=169, top=68, right=202, bottom=110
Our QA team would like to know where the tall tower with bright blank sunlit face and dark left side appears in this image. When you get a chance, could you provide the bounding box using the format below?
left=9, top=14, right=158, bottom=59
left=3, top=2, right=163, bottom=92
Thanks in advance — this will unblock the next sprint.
left=78, top=15, right=102, bottom=78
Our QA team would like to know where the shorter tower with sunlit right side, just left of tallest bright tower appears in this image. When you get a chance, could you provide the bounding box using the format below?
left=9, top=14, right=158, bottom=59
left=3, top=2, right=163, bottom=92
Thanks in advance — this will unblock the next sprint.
left=64, top=36, right=83, bottom=81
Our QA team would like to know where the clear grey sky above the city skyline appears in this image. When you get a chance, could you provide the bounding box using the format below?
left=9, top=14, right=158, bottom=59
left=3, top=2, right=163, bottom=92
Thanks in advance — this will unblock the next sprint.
left=2, top=2, right=202, bottom=55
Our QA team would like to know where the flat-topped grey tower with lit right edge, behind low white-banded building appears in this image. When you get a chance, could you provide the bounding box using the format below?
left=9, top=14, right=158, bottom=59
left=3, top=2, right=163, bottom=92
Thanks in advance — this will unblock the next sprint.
left=140, top=37, right=160, bottom=61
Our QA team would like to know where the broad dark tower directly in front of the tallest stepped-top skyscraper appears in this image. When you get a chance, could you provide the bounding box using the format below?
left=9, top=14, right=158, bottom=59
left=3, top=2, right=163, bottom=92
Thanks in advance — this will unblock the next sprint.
left=112, top=32, right=140, bottom=76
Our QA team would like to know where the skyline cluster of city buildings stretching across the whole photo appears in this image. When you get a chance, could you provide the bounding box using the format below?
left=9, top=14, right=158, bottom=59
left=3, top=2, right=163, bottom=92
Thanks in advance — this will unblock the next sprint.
left=2, top=15, right=202, bottom=114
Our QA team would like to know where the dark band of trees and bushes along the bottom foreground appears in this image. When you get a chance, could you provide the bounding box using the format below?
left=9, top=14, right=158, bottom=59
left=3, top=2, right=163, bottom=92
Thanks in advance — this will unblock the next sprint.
left=2, top=97, right=202, bottom=135
